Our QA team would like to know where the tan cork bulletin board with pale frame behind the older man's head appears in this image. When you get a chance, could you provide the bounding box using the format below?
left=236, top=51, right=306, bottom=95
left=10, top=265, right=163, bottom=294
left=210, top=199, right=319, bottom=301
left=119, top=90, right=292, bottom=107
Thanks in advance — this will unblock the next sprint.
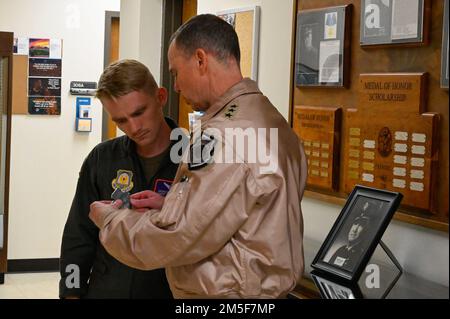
left=217, top=6, right=260, bottom=81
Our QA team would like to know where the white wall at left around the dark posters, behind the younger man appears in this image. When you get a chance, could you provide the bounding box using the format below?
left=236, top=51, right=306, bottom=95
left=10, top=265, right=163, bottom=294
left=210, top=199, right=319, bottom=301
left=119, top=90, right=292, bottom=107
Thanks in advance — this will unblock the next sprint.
left=0, top=0, right=120, bottom=259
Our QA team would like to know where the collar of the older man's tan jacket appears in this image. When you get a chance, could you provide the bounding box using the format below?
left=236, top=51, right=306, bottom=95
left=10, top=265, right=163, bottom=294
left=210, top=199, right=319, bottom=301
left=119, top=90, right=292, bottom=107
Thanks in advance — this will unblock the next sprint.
left=202, top=78, right=261, bottom=122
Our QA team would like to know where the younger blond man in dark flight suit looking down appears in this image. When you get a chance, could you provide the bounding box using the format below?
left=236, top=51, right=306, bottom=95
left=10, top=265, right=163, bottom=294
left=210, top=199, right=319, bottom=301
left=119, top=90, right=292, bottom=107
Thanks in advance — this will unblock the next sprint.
left=59, top=60, right=178, bottom=298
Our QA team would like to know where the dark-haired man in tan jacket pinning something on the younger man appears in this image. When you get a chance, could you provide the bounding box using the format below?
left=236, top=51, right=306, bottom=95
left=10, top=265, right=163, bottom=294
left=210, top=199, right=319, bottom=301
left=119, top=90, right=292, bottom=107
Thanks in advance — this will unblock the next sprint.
left=89, top=15, right=307, bottom=298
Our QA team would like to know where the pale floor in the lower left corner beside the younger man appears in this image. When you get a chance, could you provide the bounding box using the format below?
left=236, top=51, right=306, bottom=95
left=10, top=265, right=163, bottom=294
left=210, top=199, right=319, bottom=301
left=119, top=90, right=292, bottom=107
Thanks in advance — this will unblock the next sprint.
left=0, top=272, right=59, bottom=299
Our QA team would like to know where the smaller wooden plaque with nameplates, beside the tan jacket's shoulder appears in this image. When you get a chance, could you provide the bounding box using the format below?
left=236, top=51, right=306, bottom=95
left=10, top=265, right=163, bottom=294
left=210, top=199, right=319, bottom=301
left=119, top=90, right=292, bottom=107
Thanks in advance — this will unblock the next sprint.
left=293, top=106, right=342, bottom=191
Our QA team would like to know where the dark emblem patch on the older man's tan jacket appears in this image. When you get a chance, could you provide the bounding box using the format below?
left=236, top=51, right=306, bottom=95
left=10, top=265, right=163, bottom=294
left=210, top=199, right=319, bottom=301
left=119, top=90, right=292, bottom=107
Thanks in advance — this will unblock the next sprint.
left=188, top=133, right=217, bottom=171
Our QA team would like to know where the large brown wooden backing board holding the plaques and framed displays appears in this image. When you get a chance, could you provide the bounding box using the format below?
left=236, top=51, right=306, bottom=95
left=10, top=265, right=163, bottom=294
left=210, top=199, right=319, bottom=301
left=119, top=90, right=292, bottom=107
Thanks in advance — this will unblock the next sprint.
left=290, top=0, right=449, bottom=232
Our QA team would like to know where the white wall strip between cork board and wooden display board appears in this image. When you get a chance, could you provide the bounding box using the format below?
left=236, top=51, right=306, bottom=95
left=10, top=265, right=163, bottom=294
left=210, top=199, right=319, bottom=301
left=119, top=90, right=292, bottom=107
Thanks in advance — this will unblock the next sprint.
left=197, top=0, right=294, bottom=119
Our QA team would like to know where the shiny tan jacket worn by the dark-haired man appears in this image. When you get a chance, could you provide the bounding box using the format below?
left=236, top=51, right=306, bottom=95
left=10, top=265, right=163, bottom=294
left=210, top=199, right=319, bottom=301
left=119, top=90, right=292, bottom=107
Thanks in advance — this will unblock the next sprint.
left=94, top=79, right=307, bottom=298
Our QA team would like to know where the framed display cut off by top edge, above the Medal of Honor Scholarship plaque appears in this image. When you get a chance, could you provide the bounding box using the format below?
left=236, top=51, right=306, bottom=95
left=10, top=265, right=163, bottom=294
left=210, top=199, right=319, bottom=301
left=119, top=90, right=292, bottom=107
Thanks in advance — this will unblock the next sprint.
left=360, top=0, right=431, bottom=46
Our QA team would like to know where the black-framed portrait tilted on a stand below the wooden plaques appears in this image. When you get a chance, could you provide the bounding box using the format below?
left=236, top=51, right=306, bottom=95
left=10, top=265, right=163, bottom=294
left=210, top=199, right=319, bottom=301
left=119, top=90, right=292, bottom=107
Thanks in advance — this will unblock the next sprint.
left=311, top=185, right=403, bottom=282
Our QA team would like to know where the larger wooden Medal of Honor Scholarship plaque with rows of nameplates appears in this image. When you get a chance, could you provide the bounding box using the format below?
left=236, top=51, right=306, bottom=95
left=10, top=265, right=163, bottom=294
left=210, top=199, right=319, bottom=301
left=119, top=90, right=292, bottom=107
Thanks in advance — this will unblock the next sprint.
left=344, top=73, right=439, bottom=212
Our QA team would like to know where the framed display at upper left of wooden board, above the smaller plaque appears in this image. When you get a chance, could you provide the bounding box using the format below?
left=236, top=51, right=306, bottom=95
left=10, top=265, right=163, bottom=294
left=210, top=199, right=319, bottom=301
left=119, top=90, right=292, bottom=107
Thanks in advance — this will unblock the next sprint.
left=295, top=5, right=352, bottom=87
